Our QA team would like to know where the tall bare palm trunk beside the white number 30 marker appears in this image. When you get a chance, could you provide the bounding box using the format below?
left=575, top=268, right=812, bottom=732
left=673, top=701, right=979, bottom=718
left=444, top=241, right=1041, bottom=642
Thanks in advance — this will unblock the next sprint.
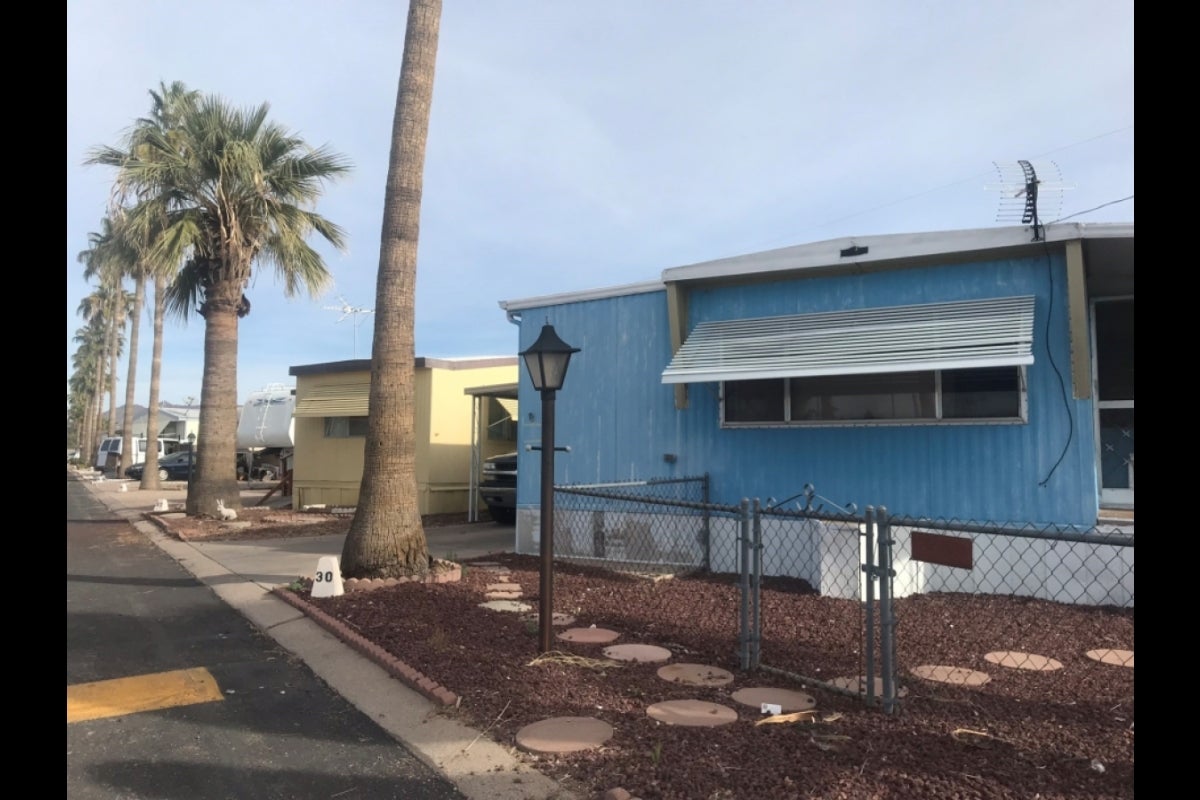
left=341, top=0, right=442, bottom=578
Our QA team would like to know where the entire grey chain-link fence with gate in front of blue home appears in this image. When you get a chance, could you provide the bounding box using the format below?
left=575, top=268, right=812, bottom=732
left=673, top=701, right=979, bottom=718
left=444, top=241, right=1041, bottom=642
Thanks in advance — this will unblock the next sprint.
left=554, top=477, right=1134, bottom=711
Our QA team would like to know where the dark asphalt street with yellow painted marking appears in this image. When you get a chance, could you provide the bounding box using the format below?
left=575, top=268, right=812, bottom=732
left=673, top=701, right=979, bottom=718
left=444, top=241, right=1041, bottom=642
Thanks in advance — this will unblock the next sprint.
left=67, top=481, right=463, bottom=800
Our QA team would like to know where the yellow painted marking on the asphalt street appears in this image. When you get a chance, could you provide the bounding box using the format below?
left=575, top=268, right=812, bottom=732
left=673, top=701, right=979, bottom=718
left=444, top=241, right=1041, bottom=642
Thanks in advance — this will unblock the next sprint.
left=67, top=667, right=224, bottom=724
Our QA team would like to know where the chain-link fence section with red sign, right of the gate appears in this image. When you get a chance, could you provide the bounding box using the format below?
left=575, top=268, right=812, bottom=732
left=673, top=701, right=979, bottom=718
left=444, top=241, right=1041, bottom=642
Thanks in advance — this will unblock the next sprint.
left=880, top=516, right=1134, bottom=708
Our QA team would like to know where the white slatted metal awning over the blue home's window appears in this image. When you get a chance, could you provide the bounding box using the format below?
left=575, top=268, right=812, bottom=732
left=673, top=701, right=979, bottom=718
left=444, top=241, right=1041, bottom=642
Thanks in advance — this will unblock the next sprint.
left=662, top=296, right=1033, bottom=384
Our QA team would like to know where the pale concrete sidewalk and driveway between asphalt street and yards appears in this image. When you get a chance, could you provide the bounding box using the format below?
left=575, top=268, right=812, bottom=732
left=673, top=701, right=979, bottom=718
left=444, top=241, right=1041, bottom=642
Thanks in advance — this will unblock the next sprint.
left=68, top=473, right=572, bottom=800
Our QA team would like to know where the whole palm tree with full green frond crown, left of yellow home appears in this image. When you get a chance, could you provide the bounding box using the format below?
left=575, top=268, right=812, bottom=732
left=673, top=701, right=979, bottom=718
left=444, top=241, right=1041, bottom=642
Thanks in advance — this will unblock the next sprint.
left=89, top=89, right=349, bottom=515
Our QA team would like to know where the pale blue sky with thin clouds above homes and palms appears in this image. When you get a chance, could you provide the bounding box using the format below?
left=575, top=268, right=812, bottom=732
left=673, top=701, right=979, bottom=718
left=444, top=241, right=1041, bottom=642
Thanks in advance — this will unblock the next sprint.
left=66, top=0, right=1134, bottom=405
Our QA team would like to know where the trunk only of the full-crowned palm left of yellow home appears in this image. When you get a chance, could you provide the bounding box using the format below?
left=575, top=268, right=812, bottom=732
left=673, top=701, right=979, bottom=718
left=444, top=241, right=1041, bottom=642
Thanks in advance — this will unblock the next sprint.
left=187, top=281, right=241, bottom=516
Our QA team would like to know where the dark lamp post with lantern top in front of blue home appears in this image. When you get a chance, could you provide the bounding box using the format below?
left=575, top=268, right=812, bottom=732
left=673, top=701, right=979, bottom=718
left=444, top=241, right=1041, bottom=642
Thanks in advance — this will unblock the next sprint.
left=520, top=323, right=580, bottom=652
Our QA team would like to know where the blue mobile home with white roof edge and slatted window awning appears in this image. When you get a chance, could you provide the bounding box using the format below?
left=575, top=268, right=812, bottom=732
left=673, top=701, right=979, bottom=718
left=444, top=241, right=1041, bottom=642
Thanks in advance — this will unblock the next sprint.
left=500, top=223, right=1133, bottom=552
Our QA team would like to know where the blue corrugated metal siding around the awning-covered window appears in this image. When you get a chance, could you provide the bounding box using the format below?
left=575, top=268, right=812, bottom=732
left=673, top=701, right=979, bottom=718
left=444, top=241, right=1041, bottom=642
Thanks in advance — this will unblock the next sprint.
left=517, top=255, right=1098, bottom=524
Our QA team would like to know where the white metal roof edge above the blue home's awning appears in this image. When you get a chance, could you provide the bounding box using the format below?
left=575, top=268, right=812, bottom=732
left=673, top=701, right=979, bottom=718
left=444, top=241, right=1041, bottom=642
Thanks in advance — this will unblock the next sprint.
left=662, top=222, right=1133, bottom=282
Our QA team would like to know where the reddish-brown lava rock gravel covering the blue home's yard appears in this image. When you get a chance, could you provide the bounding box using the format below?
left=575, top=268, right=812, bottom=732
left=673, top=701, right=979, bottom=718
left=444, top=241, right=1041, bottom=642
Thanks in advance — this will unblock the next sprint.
left=154, top=512, right=1134, bottom=800
